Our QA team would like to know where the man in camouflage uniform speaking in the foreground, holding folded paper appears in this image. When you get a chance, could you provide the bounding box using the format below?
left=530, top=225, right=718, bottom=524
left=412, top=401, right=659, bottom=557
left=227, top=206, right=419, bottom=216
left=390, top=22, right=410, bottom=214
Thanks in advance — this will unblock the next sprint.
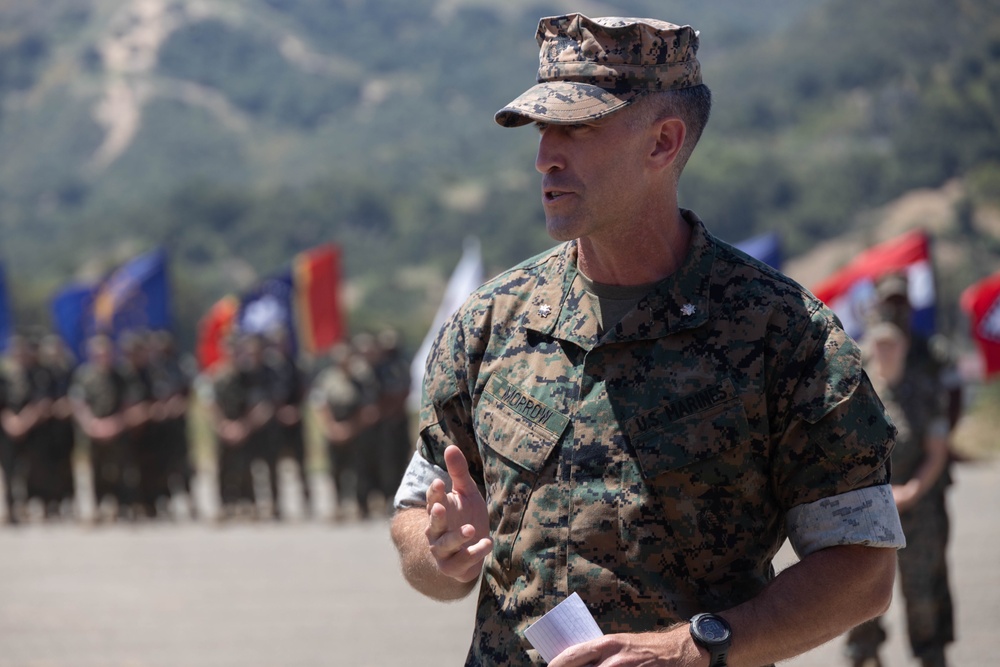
left=392, top=15, right=902, bottom=667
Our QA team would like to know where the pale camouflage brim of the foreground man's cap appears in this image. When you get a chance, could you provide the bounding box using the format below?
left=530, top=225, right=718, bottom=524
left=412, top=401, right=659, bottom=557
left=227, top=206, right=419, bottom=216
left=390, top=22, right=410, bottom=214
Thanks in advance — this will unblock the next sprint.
left=493, top=81, right=639, bottom=127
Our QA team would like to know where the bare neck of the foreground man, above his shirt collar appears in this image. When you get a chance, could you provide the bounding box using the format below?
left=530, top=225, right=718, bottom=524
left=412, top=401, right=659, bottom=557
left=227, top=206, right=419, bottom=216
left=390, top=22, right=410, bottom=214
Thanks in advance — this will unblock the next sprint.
left=577, top=209, right=691, bottom=285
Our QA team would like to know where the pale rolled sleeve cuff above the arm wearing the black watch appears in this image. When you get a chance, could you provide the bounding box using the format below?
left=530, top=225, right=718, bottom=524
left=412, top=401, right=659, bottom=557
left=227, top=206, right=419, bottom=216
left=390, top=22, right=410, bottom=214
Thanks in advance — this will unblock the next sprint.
left=785, top=484, right=906, bottom=558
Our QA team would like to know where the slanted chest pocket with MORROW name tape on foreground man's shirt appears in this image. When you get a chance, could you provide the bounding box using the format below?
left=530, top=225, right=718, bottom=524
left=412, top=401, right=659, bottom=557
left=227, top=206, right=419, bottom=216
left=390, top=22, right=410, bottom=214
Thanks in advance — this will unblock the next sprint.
left=475, top=375, right=569, bottom=569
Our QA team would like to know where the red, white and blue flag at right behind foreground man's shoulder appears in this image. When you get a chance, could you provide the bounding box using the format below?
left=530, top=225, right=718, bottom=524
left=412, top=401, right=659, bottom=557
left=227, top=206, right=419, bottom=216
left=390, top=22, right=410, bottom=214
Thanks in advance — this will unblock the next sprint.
left=813, top=229, right=936, bottom=338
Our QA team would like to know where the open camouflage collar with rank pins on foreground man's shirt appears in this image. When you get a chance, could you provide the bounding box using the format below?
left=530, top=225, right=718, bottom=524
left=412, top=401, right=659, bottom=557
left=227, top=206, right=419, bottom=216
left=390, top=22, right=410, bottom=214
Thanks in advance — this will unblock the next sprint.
left=522, top=209, right=716, bottom=350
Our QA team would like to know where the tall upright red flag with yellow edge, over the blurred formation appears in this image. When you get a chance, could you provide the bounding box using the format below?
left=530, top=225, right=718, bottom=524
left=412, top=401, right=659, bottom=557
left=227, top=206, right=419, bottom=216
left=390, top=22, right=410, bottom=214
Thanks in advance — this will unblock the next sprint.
left=293, top=244, right=345, bottom=355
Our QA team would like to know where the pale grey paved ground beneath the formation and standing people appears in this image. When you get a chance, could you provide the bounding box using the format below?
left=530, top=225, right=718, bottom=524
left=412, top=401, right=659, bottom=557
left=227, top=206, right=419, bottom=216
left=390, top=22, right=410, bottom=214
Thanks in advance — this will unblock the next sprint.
left=0, top=462, right=1000, bottom=667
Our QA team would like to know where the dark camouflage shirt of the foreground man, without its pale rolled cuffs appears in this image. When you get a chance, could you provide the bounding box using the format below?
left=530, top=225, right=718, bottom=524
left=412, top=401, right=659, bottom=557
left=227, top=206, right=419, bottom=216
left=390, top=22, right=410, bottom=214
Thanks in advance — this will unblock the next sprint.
left=421, top=211, right=894, bottom=665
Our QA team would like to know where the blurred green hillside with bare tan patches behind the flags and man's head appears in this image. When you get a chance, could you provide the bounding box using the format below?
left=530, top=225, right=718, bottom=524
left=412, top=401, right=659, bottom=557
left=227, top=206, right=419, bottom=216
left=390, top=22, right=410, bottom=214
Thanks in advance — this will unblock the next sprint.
left=0, top=0, right=1000, bottom=352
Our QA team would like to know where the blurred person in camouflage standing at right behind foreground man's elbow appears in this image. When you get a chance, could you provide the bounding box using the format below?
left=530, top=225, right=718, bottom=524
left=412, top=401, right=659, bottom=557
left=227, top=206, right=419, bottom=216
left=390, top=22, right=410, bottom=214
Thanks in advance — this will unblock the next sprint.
left=847, top=321, right=955, bottom=667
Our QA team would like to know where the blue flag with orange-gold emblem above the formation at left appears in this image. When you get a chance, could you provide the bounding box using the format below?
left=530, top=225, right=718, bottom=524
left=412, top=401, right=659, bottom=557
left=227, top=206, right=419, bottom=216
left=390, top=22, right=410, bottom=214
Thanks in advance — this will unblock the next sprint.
left=93, top=250, right=171, bottom=339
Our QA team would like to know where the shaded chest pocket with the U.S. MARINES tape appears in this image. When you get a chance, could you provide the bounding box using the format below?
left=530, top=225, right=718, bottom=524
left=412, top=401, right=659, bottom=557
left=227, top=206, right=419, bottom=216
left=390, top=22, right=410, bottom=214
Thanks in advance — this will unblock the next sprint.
left=626, top=378, right=750, bottom=483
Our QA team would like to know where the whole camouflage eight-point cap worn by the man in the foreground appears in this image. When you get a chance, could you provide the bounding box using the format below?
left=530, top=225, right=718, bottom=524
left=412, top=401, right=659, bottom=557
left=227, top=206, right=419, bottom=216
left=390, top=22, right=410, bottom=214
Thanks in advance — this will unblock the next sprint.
left=494, top=14, right=701, bottom=127
